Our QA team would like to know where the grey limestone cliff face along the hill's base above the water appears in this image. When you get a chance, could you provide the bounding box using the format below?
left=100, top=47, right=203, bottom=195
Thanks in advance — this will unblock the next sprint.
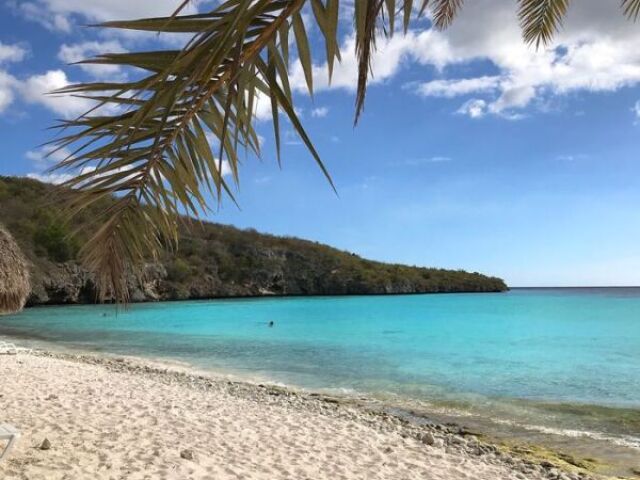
left=28, top=249, right=506, bottom=305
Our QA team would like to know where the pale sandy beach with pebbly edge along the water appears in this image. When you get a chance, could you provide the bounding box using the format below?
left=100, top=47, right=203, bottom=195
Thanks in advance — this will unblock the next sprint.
left=0, top=352, right=590, bottom=480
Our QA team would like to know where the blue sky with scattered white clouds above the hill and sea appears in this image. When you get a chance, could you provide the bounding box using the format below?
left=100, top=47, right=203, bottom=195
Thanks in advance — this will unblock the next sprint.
left=0, top=0, right=640, bottom=286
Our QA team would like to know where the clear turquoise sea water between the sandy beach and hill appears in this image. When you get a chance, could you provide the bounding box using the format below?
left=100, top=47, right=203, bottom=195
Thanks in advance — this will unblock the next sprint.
left=0, top=289, right=640, bottom=464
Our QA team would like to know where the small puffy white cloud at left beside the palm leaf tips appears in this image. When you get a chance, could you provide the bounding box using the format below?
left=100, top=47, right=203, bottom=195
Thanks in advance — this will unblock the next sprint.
left=18, top=70, right=93, bottom=118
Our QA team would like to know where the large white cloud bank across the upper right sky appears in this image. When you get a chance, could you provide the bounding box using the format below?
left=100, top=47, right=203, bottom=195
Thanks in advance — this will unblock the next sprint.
left=292, top=0, right=640, bottom=118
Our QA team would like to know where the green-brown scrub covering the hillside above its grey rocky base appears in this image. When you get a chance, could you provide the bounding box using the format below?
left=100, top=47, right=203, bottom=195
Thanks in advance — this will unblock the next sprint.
left=0, top=176, right=506, bottom=298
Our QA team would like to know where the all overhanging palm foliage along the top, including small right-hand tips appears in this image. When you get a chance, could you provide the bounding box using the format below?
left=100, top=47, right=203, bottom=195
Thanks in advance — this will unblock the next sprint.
left=48, top=0, right=640, bottom=301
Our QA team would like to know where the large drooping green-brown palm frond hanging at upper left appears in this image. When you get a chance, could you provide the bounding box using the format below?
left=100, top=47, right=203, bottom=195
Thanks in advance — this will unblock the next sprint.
left=56, top=0, right=330, bottom=300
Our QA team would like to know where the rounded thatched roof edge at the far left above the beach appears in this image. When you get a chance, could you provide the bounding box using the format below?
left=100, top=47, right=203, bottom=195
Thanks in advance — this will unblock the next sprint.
left=0, top=225, right=31, bottom=315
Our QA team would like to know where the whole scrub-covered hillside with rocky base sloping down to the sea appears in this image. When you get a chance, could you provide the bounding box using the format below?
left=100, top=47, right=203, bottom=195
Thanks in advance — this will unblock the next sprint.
left=0, top=177, right=507, bottom=305
